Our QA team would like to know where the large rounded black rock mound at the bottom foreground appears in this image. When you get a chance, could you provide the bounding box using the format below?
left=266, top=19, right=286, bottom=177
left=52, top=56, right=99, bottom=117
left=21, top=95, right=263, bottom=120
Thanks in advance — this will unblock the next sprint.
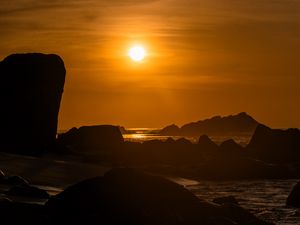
left=46, top=169, right=274, bottom=225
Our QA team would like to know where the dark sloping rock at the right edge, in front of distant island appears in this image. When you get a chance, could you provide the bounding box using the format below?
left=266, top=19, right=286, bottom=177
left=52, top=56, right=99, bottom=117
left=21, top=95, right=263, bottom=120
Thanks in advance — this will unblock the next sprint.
left=247, top=125, right=300, bottom=162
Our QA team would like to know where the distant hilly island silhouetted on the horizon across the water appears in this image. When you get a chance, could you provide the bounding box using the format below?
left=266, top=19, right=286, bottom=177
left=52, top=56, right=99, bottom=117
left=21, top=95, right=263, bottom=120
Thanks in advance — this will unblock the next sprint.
left=159, top=112, right=259, bottom=136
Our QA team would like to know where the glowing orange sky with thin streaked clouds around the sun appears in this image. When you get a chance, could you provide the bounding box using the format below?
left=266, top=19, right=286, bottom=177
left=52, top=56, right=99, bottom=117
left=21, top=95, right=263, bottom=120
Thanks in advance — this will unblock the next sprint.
left=0, top=0, right=300, bottom=129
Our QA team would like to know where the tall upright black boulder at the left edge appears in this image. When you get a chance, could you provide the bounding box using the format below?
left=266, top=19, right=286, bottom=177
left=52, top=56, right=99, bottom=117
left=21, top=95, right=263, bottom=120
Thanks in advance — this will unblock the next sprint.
left=0, top=53, right=66, bottom=154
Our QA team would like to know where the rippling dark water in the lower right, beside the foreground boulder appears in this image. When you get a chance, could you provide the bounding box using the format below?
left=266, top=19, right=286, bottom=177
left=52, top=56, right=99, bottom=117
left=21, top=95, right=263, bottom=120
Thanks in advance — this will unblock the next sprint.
left=175, top=179, right=300, bottom=225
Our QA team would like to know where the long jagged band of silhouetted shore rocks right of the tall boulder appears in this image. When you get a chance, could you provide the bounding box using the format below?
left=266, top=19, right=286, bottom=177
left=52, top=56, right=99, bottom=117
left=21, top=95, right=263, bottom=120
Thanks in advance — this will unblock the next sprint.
left=57, top=120, right=300, bottom=179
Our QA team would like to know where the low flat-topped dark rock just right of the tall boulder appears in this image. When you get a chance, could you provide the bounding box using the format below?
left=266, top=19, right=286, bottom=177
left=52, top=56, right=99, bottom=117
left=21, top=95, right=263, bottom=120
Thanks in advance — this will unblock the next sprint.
left=57, top=125, right=124, bottom=153
